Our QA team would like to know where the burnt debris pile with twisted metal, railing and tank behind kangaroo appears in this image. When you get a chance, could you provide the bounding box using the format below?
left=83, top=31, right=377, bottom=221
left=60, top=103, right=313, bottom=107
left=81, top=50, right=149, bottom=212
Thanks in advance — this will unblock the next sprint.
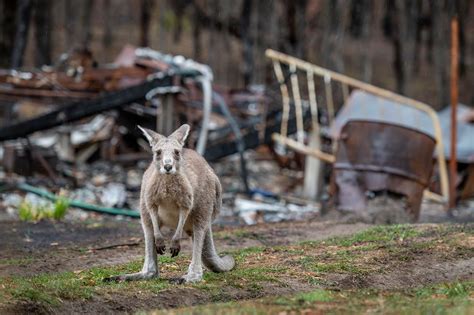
left=0, top=46, right=474, bottom=224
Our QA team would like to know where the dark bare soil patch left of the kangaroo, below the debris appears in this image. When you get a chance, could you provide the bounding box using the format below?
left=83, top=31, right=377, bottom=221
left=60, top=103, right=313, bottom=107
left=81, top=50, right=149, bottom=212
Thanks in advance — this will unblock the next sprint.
left=0, top=221, right=142, bottom=276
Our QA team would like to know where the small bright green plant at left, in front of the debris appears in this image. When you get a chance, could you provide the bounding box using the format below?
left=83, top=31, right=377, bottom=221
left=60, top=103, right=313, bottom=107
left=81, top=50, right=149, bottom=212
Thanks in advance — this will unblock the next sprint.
left=18, top=197, right=69, bottom=222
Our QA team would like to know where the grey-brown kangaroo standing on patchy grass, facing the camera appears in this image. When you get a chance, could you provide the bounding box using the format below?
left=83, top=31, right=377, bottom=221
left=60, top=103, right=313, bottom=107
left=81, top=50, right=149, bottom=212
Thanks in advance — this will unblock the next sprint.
left=107, top=124, right=235, bottom=283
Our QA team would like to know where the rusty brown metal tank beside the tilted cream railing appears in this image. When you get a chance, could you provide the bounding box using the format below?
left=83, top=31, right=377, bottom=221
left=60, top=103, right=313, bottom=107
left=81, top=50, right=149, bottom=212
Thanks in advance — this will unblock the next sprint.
left=334, top=120, right=436, bottom=220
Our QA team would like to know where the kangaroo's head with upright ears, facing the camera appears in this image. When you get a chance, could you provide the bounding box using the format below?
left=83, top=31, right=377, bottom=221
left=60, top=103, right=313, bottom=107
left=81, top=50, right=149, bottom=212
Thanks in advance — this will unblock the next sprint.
left=138, top=124, right=190, bottom=174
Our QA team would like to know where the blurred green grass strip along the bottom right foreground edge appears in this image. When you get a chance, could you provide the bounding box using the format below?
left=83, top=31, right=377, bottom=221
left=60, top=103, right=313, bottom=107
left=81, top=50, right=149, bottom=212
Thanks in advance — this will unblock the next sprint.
left=157, top=282, right=474, bottom=315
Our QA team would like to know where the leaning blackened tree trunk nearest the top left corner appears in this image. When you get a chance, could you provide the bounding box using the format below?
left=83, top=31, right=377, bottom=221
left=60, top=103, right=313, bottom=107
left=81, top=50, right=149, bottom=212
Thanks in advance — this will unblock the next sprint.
left=11, top=0, right=32, bottom=68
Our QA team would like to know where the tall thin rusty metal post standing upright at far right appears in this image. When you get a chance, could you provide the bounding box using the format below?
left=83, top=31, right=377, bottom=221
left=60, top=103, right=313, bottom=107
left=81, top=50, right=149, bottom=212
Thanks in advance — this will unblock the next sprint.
left=449, top=17, right=459, bottom=209
